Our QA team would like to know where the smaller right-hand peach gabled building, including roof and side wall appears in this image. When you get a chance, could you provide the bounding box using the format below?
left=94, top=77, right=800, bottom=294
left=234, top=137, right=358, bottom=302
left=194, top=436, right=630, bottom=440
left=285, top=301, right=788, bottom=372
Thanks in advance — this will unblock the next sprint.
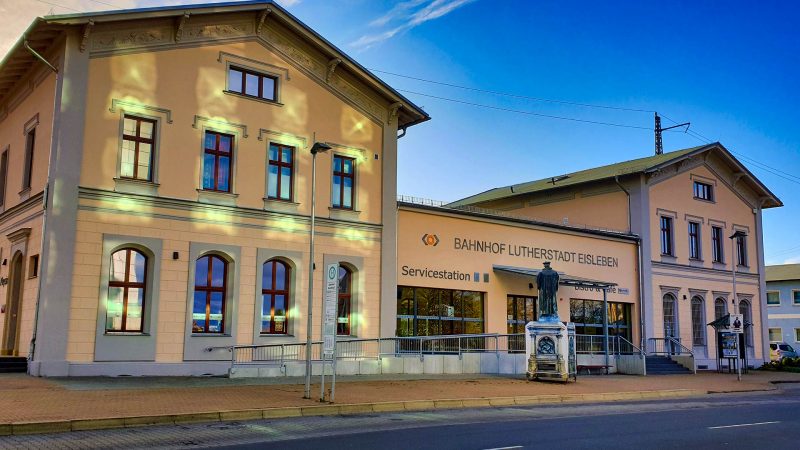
left=449, top=143, right=782, bottom=369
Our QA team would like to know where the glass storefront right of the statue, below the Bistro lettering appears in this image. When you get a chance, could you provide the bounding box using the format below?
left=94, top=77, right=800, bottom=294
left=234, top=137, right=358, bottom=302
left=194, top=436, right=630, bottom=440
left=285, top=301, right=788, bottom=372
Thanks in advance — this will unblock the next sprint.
left=569, top=298, right=632, bottom=341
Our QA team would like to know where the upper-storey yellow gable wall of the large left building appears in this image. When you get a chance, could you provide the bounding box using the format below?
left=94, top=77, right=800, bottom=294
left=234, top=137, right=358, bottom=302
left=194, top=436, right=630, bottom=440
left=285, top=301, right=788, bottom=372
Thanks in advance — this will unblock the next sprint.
left=81, top=42, right=383, bottom=223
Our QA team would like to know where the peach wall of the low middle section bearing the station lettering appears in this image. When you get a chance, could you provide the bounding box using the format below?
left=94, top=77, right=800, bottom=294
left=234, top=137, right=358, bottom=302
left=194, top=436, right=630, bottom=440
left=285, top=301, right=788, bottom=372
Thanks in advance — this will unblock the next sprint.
left=397, top=208, right=639, bottom=342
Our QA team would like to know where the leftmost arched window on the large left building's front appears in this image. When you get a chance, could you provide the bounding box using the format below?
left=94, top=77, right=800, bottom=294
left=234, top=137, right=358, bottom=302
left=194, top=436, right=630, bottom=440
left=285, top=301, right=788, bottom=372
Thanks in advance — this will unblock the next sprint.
left=106, top=248, right=147, bottom=332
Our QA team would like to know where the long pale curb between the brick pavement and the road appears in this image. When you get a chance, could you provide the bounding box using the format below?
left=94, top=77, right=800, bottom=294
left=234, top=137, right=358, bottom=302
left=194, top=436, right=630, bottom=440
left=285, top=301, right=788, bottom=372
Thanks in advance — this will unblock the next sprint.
left=0, top=389, right=711, bottom=436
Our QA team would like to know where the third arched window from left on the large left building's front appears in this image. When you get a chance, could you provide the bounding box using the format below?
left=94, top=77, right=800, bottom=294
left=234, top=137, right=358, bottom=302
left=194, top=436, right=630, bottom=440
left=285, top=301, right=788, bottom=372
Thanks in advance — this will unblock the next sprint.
left=261, top=259, right=291, bottom=334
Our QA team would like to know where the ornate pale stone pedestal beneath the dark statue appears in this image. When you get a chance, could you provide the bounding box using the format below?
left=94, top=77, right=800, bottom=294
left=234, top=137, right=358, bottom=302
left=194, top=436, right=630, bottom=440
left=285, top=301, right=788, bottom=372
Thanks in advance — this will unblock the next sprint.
left=525, top=321, right=578, bottom=383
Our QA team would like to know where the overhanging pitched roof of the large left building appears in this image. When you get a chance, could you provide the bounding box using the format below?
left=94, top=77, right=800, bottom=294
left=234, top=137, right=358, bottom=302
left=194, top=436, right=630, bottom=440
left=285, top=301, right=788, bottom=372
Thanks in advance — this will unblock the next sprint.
left=0, top=0, right=430, bottom=128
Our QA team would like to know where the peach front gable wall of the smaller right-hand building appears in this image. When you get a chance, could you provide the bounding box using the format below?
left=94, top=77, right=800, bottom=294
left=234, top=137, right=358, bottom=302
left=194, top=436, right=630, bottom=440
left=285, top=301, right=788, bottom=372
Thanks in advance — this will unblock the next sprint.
left=650, top=165, right=764, bottom=358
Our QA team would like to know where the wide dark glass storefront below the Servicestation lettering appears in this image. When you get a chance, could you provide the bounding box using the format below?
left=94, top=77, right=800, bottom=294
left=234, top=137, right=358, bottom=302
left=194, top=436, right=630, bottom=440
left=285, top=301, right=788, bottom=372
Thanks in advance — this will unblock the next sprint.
left=396, top=286, right=484, bottom=336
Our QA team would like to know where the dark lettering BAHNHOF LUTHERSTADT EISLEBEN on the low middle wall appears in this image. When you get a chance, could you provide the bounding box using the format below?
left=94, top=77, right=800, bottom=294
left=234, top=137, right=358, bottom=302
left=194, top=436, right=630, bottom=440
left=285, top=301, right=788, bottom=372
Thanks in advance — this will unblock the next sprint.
left=453, top=238, right=619, bottom=267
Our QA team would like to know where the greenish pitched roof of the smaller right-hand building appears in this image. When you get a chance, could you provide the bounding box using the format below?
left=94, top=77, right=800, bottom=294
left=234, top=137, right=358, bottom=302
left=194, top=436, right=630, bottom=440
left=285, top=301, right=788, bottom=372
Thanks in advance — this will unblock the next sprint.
left=450, top=142, right=783, bottom=207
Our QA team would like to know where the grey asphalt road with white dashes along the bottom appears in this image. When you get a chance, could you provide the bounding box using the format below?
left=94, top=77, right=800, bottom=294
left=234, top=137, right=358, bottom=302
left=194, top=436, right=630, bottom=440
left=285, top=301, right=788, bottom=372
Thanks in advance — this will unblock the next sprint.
left=0, top=385, right=800, bottom=450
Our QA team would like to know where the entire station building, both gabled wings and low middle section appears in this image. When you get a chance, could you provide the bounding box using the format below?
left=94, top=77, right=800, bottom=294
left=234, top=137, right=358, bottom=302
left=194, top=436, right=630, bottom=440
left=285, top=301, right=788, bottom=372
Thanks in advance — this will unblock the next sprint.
left=0, top=1, right=780, bottom=376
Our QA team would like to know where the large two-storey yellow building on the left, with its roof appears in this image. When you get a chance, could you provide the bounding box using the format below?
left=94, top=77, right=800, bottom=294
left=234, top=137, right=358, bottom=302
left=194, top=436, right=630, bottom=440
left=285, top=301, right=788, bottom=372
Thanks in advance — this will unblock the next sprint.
left=0, top=1, right=429, bottom=376
